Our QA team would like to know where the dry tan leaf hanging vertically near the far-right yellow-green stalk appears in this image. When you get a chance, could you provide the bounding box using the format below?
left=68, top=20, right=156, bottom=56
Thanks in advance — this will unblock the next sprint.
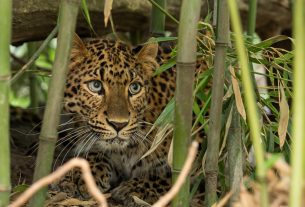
left=278, top=83, right=289, bottom=149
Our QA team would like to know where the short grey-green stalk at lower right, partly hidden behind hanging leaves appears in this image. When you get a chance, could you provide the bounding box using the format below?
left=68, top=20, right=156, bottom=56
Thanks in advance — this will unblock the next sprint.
left=227, top=103, right=243, bottom=206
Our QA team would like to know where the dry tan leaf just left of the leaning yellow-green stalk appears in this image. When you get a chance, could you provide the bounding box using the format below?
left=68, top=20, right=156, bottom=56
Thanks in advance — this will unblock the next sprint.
left=230, top=67, right=247, bottom=121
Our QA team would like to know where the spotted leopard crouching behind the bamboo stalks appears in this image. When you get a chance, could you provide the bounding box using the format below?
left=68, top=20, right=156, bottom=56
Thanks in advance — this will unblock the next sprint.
left=54, top=35, right=176, bottom=207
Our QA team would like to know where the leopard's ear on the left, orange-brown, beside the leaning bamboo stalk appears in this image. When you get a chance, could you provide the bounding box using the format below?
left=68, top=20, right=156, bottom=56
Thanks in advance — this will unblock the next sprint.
left=71, top=33, right=89, bottom=60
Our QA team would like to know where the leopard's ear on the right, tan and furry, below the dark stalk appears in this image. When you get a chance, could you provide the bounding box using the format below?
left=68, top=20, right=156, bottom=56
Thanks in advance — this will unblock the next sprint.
left=137, top=40, right=159, bottom=76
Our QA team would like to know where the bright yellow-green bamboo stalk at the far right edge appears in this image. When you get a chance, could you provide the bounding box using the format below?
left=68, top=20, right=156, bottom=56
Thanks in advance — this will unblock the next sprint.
left=289, top=0, right=305, bottom=206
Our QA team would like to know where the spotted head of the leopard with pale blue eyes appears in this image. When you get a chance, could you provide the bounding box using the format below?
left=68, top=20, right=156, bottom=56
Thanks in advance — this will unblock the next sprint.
left=64, top=36, right=158, bottom=149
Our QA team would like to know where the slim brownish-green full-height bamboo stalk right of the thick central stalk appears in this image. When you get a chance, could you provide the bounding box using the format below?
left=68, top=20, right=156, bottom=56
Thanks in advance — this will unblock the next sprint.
left=205, top=1, right=230, bottom=206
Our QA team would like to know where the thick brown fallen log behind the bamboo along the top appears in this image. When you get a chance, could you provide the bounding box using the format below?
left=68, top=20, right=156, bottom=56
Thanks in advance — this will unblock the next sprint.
left=12, top=0, right=291, bottom=44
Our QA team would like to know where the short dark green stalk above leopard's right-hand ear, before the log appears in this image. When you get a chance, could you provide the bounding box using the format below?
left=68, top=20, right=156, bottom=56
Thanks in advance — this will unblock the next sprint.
left=150, top=0, right=166, bottom=37
